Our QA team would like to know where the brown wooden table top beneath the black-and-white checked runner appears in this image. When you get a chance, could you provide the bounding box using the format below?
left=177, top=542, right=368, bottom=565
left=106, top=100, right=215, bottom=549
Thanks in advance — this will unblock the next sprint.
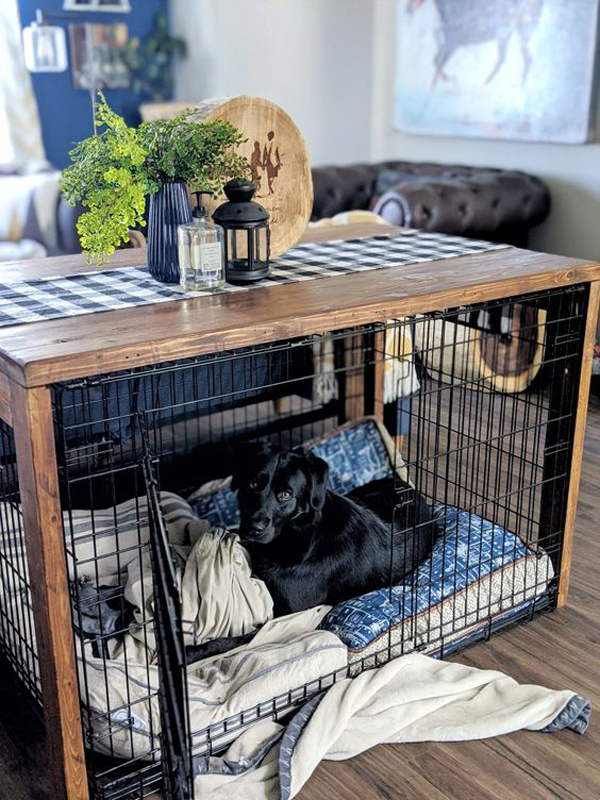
left=0, top=223, right=600, bottom=390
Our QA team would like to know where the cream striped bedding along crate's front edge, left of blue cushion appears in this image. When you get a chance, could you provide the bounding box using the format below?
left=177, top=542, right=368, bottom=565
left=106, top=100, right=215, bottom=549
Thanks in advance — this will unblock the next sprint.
left=84, top=606, right=348, bottom=760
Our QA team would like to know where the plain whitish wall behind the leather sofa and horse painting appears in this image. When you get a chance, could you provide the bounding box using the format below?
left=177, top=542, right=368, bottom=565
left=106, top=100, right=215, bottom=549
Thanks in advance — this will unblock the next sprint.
left=171, top=0, right=600, bottom=259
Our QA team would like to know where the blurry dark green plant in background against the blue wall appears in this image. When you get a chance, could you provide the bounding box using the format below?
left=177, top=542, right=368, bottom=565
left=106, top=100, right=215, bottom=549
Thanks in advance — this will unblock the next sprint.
left=120, top=14, right=187, bottom=102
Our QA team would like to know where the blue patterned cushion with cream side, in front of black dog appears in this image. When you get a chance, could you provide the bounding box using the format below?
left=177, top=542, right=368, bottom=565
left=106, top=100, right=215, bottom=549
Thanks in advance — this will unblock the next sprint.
left=321, top=505, right=553, bottom=654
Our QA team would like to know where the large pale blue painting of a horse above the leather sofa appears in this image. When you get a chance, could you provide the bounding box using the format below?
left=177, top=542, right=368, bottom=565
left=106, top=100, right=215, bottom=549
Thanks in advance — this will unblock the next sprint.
left=394, top=0, right=599, bottom=143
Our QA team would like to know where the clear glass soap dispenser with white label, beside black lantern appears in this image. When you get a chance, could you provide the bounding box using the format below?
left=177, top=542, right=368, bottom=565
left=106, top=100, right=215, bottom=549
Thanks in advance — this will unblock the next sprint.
left=177, top=192, right=225, bottom=292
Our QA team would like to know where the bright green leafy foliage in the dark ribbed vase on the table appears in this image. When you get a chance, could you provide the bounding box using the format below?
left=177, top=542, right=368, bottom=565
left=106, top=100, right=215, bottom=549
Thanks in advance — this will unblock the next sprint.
left=62, top=95, right=249, bottom=265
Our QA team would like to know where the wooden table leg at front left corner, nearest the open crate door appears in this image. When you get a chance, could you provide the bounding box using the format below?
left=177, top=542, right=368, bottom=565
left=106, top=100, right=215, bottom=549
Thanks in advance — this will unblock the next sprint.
left=10, top=383, right=89, bottom=800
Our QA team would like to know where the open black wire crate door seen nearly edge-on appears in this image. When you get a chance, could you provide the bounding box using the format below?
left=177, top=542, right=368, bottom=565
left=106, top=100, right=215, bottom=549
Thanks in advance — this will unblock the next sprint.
left=144, top=443, right=194, bottom=800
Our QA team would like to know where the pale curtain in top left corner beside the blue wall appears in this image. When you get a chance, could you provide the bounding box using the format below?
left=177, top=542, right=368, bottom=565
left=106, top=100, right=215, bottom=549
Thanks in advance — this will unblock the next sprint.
left=0, top=0, right=45, bottom=167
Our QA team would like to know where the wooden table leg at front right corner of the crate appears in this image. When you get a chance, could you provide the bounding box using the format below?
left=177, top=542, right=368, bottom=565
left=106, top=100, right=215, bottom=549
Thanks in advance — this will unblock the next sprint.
left=557, top=282, right=600, bottom=608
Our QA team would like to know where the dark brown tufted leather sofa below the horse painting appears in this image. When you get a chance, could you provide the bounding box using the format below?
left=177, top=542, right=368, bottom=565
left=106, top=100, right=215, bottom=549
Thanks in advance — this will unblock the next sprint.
left=312, top=161, right=550, bottom=247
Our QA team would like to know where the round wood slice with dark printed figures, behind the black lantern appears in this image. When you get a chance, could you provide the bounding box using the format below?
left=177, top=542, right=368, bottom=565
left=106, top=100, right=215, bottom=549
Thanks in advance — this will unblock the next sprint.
left=141, top=95, right=313, bottom=257
